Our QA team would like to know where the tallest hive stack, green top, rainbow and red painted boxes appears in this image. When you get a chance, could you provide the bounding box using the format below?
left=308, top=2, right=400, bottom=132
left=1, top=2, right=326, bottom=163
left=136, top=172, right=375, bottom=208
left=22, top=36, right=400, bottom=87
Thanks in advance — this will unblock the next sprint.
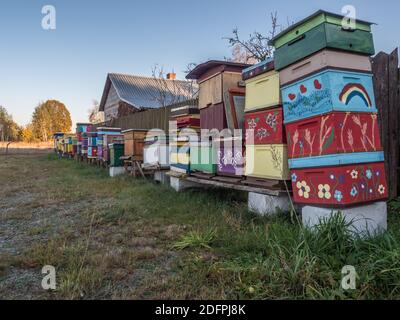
left=271, top=11, right=388, bottom=210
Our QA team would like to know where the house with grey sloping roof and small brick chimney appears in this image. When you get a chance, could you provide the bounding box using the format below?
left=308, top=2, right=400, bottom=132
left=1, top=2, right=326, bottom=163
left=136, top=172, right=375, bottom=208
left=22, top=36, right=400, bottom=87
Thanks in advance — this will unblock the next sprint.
left=99, top=73, right=197, bottom=121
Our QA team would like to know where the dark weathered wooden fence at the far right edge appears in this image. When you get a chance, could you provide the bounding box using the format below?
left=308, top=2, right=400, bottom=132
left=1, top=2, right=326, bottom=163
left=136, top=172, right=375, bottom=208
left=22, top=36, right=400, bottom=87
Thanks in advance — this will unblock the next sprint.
left=372, top=49, right=400, bottom=198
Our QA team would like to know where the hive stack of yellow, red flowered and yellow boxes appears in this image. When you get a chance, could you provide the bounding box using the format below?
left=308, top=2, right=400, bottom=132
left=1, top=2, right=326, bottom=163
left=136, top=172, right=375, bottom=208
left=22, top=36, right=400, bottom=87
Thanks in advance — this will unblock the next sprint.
left=243, top=60, right=290, bottom=187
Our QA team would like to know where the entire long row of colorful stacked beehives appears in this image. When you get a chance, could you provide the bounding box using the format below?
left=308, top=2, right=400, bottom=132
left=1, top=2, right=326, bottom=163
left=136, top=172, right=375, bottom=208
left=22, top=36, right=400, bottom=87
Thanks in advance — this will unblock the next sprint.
left=53, top=11, right=388, bottom=206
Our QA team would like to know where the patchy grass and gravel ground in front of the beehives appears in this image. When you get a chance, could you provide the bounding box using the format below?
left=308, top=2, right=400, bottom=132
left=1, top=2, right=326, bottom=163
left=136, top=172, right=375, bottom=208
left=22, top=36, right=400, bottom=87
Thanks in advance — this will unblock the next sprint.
left=0, top=154, right=400, bottom=299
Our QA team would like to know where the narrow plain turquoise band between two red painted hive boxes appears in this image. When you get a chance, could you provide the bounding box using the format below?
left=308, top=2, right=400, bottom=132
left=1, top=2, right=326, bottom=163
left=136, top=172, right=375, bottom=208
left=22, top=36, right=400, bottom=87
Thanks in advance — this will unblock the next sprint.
left=289, top=152, right=385, bottom=169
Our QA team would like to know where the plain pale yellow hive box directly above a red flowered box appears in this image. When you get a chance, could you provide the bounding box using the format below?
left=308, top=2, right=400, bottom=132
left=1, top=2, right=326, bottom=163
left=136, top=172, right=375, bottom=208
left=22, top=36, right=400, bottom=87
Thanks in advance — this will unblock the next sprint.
left=245, top=71, right=282, bottom=111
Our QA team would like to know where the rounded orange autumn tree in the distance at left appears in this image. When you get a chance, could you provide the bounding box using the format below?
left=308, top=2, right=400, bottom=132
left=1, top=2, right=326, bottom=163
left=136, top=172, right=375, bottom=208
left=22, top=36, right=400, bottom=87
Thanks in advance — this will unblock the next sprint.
left=32, top=100, right=72, bottom=142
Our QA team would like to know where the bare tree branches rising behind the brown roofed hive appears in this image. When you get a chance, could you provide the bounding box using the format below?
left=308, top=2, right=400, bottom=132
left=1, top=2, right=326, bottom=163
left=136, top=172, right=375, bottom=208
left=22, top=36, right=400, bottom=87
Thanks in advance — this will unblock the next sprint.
left=224, top=12, right=290, bottom=63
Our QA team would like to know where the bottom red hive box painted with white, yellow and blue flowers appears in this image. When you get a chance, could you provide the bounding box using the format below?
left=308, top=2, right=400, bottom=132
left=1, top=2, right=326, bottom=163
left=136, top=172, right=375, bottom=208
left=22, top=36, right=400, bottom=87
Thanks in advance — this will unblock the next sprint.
left=292, top=162, right=388, bottom=207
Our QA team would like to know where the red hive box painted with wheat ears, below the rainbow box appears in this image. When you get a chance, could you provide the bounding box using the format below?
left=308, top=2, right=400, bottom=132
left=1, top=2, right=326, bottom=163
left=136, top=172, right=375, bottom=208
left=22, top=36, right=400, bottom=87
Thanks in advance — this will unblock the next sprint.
left=286, top=112, right=382, bottom=159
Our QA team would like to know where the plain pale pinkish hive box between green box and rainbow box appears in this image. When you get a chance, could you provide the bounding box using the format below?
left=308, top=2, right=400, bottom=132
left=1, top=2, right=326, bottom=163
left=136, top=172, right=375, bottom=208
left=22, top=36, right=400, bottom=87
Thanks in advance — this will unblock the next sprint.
left=279, top=49, right=372, bottom=86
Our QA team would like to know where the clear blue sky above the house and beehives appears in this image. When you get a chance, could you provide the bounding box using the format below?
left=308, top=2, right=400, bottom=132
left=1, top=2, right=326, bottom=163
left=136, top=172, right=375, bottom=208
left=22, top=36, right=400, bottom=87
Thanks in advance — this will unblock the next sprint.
left=0, top=0, right=400, bottom=124
